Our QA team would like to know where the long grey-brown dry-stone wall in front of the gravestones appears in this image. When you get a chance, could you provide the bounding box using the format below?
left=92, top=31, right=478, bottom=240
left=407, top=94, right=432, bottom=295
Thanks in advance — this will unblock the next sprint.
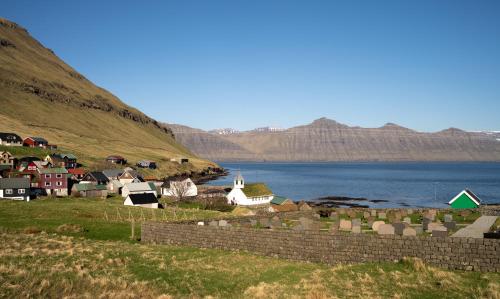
left=142, top=222, right=500, bottom=272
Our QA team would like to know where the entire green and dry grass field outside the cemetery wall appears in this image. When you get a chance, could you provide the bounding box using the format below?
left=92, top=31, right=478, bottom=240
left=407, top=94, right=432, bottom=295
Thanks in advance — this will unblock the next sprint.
left=0, top=198, right=500, bottom=298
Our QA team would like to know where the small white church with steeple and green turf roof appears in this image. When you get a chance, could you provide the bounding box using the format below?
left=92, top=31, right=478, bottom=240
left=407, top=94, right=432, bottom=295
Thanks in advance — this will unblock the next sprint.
left=226, top=173, right=274, bottom=206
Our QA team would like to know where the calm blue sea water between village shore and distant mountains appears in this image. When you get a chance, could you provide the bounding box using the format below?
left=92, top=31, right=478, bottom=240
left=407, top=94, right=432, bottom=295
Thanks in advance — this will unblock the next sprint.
left=206, top=162, right=500, bottom=207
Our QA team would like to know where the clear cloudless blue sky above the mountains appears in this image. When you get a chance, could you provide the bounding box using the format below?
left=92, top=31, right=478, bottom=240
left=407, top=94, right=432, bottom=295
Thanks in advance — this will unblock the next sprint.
left=0, top=0, right=500, bottom=131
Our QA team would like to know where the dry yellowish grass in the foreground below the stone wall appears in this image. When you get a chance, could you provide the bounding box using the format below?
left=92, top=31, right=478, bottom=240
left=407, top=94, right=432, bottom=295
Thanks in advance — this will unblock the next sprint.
left=0, top=233, right=500, bottom=298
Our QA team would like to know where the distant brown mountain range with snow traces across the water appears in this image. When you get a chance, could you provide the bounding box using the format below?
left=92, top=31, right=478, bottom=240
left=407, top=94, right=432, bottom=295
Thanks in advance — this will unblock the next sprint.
left=167, top=118, right=500, bottom=161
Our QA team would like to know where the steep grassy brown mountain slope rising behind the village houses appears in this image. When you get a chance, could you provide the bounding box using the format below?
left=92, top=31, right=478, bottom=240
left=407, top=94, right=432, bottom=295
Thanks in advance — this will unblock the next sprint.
left=0, top=19, right=214, bottom=174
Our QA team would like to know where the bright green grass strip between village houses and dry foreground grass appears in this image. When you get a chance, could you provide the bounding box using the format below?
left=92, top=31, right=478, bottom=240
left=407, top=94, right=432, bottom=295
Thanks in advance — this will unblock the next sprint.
left=0, top=197, right=226, bottom=241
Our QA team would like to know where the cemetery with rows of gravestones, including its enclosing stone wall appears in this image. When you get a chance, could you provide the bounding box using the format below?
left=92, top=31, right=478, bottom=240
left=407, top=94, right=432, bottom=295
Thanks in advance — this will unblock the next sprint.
left=141, top=208, right=500, bottom=272
